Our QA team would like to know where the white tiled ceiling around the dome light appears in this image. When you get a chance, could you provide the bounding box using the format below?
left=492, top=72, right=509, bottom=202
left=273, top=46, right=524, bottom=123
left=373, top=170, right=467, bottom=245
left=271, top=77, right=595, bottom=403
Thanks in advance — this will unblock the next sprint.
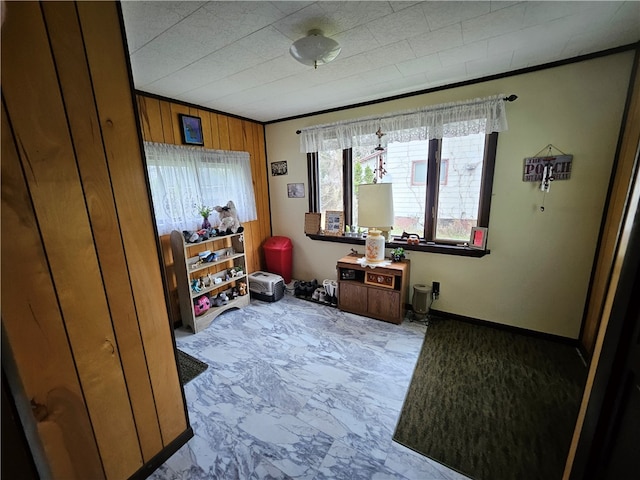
left=122, top=0, right=640, bottom=122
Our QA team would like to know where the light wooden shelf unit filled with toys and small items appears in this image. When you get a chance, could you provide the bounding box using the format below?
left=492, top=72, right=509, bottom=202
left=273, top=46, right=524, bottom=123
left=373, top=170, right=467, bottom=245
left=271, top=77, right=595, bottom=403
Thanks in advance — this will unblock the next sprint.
left=171, top=230, right=250, bottom=333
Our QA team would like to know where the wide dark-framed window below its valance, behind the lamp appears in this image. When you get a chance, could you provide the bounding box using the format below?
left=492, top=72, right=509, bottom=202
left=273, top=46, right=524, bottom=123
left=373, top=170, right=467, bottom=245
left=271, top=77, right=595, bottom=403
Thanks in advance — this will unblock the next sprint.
left=309, top=133, right=497, bottom=244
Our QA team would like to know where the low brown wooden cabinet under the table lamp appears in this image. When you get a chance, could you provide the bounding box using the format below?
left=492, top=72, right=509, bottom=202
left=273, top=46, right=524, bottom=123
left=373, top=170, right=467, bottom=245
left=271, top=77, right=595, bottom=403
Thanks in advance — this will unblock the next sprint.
left=336, top=256, right=410, bottom=324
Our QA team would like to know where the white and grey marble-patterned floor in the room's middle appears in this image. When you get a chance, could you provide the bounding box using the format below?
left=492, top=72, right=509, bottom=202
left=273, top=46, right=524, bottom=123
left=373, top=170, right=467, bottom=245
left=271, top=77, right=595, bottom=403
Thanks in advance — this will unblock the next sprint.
left=150, top=294, right=467, bottom=480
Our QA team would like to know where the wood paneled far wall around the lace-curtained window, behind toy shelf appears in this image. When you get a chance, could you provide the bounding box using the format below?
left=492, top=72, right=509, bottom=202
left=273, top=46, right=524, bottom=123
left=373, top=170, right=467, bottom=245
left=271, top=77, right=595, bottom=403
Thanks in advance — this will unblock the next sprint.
left=137, top=94, right=271, bottom=323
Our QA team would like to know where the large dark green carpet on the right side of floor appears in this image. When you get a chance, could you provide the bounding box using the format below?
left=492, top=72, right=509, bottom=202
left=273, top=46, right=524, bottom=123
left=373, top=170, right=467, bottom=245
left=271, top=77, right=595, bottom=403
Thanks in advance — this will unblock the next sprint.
left=394, top=320, right=587, bottom=480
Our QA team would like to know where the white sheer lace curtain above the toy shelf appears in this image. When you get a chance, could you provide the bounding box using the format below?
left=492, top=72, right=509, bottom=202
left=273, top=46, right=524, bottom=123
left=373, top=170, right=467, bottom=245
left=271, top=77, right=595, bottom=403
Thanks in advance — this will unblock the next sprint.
left=144, top=142, right=257, bottom=235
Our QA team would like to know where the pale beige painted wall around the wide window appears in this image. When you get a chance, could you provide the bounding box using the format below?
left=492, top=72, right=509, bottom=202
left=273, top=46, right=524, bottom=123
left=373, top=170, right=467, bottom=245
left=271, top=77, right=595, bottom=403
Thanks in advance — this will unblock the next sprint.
left=266, top=52, right=633, bottom=338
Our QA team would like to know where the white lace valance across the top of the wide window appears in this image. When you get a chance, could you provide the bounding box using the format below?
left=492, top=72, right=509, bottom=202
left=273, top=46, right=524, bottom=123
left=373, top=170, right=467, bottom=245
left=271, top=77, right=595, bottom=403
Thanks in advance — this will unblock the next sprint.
left=300, top=95, right=507, bottom=153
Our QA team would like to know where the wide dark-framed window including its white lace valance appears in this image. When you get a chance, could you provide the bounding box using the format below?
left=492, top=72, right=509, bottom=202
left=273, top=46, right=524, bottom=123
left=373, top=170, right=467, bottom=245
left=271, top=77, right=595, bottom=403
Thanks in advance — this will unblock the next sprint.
left=298, top=95, right=510, bottom=249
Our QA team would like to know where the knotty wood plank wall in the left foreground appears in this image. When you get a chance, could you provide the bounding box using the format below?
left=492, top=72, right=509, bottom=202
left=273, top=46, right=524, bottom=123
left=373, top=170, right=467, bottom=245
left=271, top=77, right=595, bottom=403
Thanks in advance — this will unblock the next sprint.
left=1, top=1, right=192, bottom=479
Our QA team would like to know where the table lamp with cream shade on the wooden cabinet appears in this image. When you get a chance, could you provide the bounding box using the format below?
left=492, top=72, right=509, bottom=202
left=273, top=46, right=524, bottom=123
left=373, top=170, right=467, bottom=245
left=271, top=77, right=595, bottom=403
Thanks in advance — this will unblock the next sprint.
left=358, top=183, right=394, bottom=264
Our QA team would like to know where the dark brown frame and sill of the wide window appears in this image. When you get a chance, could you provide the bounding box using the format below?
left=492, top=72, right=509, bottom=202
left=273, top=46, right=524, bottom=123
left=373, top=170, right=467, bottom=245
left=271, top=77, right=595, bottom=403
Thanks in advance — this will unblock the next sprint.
left=307, top=132, right=498, bottom=257
